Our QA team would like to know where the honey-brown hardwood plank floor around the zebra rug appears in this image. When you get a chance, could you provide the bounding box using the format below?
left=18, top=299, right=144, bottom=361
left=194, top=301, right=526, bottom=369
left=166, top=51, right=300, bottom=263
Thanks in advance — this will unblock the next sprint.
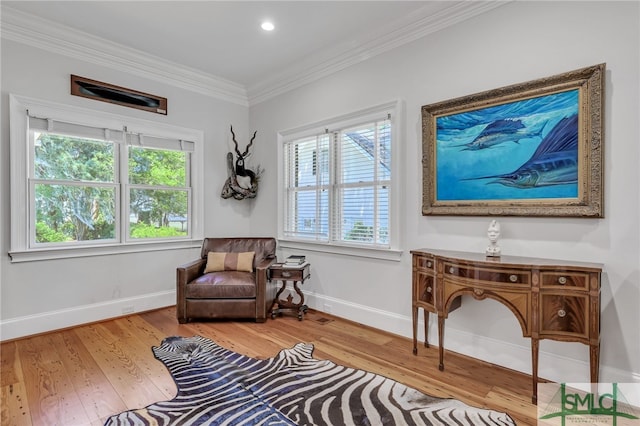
left=0, top=308, right=536, bottom=426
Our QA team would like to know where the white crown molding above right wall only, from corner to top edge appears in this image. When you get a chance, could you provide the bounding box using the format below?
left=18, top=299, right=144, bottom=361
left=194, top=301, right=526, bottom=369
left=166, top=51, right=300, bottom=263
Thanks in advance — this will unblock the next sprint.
left=247, top=0, right=513, bottom=105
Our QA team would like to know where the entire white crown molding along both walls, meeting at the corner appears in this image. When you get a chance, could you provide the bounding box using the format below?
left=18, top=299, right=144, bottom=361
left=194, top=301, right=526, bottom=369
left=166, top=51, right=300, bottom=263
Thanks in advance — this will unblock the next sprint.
left=0, top=0, right=513, bottom=106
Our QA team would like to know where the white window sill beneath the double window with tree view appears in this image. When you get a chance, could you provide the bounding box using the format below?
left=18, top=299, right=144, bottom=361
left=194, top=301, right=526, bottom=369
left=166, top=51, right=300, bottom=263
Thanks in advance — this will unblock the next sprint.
left=9, top=239, right=202, bottom=263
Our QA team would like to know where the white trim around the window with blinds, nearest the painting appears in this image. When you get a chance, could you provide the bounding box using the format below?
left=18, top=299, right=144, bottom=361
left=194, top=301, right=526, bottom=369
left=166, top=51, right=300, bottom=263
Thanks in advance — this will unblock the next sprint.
left=277, top=100, right=404, bottom=261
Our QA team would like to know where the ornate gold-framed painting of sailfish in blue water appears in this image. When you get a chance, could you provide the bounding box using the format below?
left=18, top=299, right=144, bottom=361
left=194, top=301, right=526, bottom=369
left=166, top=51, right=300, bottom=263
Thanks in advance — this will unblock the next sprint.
left=422, top=64, right=605, bottom=218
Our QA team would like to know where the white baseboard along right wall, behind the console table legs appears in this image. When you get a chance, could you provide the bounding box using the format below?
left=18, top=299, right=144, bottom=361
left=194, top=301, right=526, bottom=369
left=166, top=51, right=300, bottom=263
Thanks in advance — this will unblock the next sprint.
left=305, top=292, right=640, bottom=383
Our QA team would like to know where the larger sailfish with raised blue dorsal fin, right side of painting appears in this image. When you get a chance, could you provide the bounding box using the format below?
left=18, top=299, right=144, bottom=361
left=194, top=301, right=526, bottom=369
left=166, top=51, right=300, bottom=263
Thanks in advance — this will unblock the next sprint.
left=464, top=114, right=578, bottom=189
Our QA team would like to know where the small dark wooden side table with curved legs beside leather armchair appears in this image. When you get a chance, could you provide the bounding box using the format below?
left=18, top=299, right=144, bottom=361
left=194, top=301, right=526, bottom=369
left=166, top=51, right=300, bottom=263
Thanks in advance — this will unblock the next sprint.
left=269, top=263, right=311, bottom=321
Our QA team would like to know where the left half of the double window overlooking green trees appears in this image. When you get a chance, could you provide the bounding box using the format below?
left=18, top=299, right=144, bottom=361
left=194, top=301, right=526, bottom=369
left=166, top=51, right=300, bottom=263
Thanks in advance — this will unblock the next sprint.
left=29, top=126, right=117, bottom=247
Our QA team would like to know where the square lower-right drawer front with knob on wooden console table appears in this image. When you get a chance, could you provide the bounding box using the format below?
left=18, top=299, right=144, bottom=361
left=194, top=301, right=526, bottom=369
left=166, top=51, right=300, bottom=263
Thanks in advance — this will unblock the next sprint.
left=540, top=294, right=589, bottom=339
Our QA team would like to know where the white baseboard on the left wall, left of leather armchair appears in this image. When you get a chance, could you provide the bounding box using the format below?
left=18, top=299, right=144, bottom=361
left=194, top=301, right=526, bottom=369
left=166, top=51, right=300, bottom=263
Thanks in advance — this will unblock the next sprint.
left=0, top=290, right=176, bottom=341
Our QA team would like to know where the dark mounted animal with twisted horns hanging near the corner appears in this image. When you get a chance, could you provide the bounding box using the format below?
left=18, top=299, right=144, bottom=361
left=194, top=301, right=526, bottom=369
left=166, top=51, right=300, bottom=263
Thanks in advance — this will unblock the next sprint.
left=221, top=126, right=261, bottom=200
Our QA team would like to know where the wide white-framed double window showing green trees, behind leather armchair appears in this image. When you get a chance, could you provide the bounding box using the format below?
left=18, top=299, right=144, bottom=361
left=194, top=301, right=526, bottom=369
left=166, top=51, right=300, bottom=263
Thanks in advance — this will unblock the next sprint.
left=11, top=95, right=202, bottom=261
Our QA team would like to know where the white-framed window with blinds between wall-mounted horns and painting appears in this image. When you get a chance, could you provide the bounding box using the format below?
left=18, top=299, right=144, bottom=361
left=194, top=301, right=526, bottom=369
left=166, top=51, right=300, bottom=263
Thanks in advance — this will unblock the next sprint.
left=280, top=103, right=397, bottom=250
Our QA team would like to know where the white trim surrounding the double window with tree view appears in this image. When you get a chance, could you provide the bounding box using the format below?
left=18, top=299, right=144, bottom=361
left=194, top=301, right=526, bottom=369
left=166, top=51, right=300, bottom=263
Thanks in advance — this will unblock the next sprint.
left=9, top=94, right=204, bottom=262
